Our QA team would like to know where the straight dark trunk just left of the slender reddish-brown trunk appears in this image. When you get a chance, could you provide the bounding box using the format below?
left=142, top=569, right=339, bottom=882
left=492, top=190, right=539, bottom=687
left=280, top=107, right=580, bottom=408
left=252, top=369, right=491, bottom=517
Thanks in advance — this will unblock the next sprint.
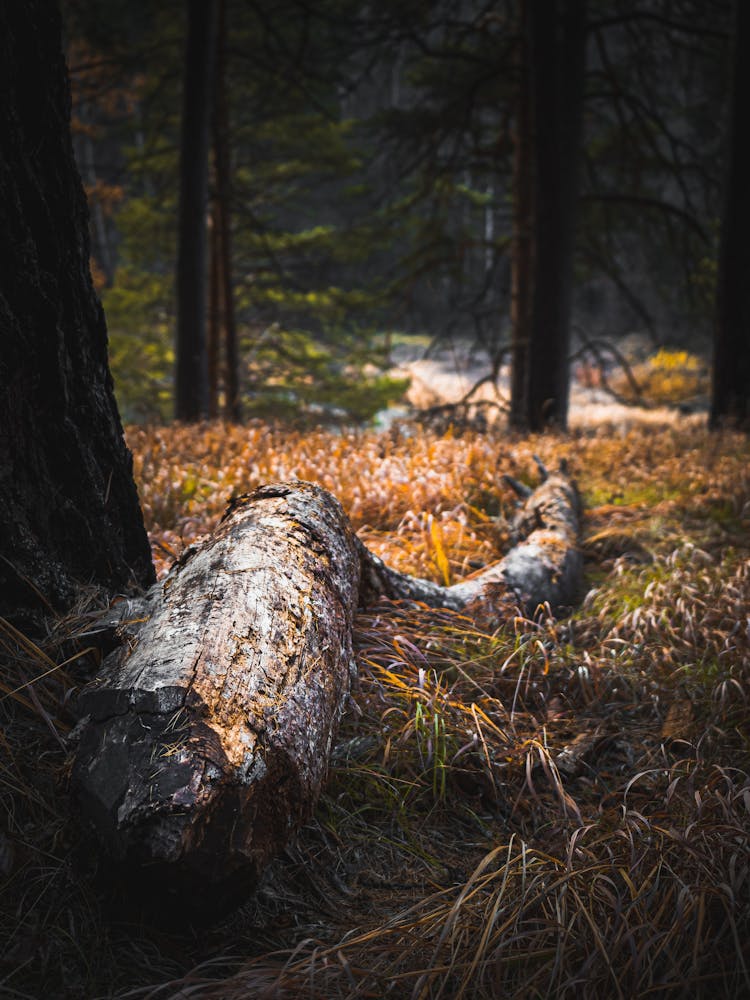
left=175, top=0, right=216, bottom=421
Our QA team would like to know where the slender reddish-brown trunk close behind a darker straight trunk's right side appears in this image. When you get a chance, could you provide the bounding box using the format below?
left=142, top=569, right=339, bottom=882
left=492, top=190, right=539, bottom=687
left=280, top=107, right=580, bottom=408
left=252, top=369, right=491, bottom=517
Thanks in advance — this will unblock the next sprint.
left=214, top=0, right=242, bottom=422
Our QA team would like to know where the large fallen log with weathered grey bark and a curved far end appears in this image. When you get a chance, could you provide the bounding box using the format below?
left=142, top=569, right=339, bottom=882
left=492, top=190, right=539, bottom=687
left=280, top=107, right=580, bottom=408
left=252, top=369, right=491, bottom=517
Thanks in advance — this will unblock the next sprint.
left=73, top=464, right=581, bottom=905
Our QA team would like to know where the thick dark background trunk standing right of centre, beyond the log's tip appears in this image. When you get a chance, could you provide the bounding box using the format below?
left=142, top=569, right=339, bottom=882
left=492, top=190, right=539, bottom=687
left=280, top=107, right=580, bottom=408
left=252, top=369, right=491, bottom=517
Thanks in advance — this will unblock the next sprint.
left=511, top=0, right=586, bottom=430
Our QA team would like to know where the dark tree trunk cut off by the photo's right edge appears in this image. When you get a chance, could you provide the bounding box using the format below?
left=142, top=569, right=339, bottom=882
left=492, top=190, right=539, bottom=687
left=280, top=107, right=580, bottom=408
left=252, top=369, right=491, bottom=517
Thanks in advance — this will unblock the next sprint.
left=710, top=0, right=750, bottom=430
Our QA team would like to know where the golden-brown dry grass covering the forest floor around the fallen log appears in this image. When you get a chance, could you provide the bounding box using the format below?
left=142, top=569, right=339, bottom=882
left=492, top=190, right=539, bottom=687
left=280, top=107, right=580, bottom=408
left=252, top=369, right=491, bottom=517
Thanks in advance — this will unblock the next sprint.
left=0, top=402, right=750, bottom=1000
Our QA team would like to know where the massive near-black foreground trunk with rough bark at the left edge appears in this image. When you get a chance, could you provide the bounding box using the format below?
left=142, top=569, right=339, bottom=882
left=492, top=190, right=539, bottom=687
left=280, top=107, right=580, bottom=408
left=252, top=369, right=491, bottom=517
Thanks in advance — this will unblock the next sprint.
left=0, top=0, right=153, bottom=617
